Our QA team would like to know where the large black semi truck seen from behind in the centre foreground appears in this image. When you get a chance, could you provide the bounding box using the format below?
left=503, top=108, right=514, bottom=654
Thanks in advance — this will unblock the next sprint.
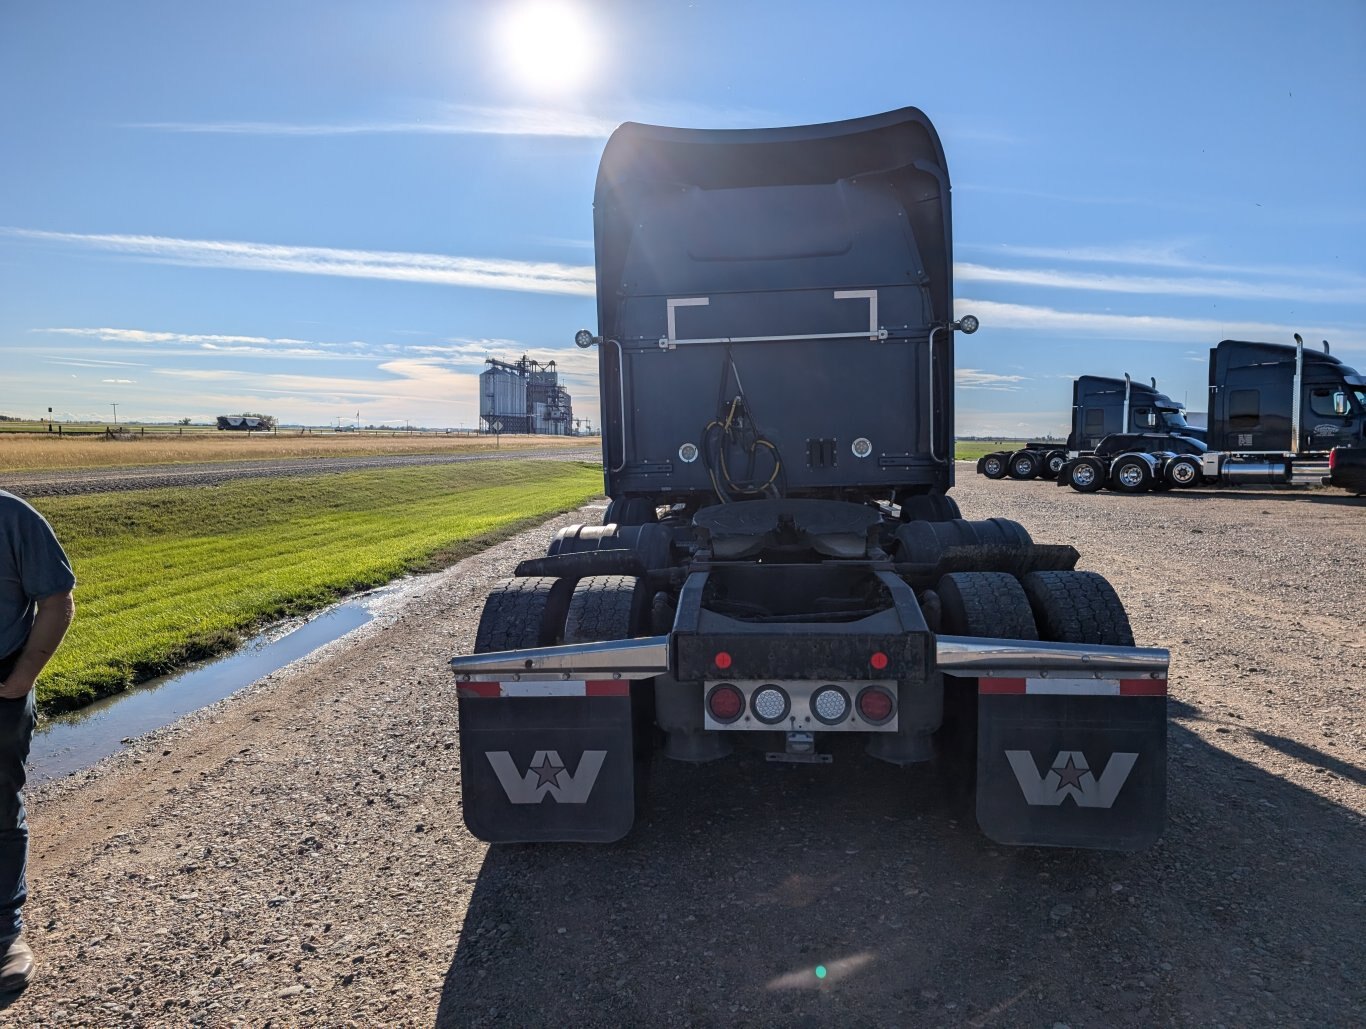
left=451, top=108, right=1168, bottom=850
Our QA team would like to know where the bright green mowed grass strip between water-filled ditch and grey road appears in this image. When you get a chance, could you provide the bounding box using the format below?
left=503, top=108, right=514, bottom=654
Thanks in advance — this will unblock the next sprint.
left=34, top=461, right=602, bottom=712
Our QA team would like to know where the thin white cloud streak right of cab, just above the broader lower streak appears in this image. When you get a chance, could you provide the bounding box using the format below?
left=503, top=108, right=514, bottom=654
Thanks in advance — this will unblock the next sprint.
left=953, top=264, right=1366, bottom=303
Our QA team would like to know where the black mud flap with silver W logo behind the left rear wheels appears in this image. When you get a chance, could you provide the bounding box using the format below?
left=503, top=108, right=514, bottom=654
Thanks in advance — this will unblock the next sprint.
left=460, top=696, right=635, bottom=843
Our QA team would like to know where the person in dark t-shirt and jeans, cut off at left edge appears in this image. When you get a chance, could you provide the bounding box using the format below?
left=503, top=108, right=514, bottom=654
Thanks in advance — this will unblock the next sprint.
left=0, top=489, right=76, bottom=993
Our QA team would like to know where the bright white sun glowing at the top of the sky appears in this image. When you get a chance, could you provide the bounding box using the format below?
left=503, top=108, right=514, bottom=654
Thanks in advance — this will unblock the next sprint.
left=497, top=0, right=598, bottom=93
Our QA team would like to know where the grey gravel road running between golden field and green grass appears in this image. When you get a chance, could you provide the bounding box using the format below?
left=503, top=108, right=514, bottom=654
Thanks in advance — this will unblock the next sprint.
left=0, top=443, right=600, bottom=500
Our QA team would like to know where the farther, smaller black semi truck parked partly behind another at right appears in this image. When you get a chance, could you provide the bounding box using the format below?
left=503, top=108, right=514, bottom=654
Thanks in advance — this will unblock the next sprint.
left=977, top=373, right=1205, bottom=480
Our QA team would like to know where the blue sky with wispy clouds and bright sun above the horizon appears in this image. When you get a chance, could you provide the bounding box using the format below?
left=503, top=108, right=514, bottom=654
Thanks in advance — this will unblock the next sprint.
left=0, top=0, right=1366, bottom=435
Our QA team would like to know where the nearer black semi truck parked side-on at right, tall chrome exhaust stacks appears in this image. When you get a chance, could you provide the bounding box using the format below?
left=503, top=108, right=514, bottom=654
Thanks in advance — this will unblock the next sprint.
left=1057, top=333, right=1366, bottom=493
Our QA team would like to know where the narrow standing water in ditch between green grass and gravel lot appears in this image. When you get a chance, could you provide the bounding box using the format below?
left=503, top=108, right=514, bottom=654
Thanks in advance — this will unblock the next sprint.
left=29, top=579, right=411, bottom=783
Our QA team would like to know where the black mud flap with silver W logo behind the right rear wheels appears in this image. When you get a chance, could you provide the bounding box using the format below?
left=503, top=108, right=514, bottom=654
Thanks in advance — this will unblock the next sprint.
left=977, top=691, right=1167, bottom=850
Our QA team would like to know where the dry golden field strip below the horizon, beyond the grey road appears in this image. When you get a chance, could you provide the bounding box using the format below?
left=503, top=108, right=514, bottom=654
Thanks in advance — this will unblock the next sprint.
left=0, top=432, right=598, bottom=474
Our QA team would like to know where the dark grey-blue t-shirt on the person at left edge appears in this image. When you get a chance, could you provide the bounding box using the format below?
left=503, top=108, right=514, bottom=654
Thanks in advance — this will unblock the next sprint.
left=0, top=489, right=76, bottom=657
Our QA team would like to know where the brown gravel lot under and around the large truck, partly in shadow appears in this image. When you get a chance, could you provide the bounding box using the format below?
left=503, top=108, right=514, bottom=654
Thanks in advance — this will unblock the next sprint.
left=0, top=478, right=1366, bottom=1026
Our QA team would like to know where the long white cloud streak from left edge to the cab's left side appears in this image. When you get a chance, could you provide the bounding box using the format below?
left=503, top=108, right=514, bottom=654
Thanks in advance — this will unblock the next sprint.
left=3, top=228, right=594, bottom=297
